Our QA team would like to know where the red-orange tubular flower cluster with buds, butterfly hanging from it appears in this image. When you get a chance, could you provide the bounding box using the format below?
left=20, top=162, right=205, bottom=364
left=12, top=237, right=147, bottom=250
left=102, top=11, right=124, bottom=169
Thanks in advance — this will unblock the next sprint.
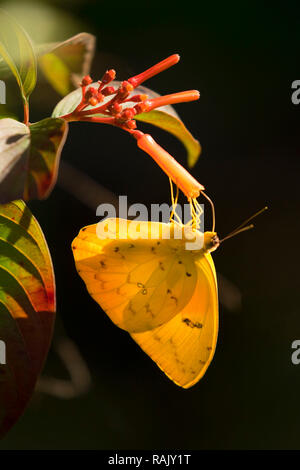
left=62, top=54, right=204, bottom=199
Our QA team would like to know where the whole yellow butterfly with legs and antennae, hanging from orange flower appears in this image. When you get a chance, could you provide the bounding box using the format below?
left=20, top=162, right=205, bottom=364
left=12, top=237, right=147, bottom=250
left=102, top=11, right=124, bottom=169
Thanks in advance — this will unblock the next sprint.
left=72, top=178, right=262, bottom=388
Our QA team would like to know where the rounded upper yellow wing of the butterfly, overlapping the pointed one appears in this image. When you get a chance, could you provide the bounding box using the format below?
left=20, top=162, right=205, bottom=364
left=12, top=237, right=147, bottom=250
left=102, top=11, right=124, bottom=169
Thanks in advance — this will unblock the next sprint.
left=72, top=219, right=197, bottom=333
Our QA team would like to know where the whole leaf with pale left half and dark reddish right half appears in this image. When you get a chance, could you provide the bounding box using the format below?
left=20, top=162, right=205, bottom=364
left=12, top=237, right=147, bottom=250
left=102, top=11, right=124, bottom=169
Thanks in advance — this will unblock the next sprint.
left=0, top=118, right=68, bottom=204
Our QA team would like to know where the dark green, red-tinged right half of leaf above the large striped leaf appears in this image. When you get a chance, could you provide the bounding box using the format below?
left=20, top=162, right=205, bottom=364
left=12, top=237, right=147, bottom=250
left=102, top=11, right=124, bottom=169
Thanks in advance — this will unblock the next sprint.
left=24, top=118, right=68, bottom=200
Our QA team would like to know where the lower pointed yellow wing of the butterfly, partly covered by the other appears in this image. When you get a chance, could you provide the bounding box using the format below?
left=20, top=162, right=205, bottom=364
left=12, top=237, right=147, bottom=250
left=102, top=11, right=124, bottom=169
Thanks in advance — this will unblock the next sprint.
left=131, top=254, right=218, bottom=388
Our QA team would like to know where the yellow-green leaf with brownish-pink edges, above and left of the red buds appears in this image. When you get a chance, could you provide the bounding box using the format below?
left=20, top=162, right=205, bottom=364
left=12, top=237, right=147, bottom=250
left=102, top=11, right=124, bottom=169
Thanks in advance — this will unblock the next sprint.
left=36, top=33, right=96, bottom=96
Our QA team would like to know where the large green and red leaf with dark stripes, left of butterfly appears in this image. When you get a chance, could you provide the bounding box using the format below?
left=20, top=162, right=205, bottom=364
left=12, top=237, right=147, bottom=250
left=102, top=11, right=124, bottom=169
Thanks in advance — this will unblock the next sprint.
left=0, top=201, right=55, bottom=436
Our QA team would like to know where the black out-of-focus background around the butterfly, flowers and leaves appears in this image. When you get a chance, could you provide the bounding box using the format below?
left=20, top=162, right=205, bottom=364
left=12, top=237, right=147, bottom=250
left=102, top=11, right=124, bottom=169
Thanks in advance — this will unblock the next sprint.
left=0, top=0, right=300, bottom=449
